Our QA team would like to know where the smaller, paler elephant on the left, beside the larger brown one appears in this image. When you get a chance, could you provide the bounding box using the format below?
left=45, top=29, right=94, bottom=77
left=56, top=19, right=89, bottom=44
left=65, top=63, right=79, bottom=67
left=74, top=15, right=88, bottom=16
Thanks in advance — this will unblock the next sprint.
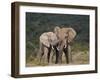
left=39, top=32, right=59, bottom=63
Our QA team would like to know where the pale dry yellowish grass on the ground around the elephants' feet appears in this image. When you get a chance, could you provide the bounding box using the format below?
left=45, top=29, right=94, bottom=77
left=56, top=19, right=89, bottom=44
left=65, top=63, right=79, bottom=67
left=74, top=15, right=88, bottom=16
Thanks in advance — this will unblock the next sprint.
left=26, top=51, right=89, bottom=67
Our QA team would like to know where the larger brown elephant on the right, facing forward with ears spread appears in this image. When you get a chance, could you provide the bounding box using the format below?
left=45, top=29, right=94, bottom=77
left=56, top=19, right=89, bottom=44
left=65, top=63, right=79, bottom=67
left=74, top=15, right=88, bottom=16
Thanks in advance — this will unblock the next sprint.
left=54, top=27, right=76, bottom=63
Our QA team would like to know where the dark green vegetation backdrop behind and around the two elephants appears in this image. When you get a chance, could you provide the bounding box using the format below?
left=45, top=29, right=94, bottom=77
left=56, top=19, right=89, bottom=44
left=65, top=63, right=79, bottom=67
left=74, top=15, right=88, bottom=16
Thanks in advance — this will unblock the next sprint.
left=26, top=12, right=89, bottom=66
